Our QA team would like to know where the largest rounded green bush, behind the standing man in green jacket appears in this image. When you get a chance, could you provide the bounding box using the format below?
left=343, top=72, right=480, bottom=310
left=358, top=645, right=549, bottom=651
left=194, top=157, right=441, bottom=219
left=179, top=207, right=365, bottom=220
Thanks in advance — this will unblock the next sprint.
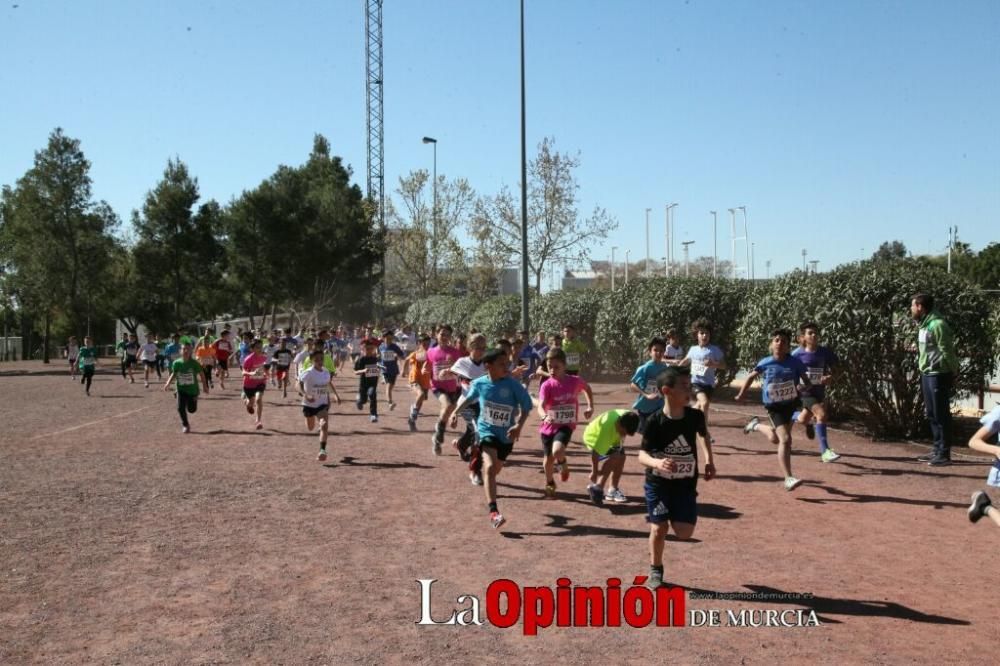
left=737, top=260, right=998, bottom=437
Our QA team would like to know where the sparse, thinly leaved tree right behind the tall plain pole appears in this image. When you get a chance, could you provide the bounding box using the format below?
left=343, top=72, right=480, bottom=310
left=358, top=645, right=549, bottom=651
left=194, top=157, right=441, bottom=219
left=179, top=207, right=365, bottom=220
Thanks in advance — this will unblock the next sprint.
left=470, top=138, right=618, bottom=291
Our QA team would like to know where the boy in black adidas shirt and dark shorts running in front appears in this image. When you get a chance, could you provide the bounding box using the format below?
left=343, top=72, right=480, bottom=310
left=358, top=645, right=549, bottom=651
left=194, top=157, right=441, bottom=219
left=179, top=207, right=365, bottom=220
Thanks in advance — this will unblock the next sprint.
left=639, top=366, right=715, bottom=588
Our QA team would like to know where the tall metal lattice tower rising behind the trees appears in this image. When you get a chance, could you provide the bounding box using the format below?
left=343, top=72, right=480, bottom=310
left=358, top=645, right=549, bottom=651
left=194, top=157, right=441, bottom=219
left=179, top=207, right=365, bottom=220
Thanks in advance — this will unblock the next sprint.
left=364, top=0, right=385, bottom=308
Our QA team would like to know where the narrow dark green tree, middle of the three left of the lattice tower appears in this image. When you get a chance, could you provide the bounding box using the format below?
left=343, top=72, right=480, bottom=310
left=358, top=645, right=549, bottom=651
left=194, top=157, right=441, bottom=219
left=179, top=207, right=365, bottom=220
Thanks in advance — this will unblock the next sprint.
left=132, top=159, right=222, bottom=330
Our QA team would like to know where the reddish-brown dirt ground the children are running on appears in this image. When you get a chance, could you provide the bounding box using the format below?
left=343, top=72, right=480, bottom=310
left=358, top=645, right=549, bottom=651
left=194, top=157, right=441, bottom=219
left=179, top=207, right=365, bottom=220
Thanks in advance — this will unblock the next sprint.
left=0, top=364, right=1000, bottom=664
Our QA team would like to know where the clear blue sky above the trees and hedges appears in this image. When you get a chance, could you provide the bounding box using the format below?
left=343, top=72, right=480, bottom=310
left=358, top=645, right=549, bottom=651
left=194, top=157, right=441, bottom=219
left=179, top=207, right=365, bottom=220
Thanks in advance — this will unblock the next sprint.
left=0, top=0, right=1000, bottom=288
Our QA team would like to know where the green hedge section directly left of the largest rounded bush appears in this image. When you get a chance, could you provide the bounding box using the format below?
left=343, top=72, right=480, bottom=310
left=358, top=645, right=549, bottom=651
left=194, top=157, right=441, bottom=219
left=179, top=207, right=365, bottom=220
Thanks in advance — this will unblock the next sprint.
left=596, top=277, right=753, bottom=384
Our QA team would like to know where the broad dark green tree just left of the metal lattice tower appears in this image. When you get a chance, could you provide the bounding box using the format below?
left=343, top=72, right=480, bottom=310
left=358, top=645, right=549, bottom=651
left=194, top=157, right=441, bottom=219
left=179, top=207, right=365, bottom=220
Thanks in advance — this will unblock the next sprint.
left=224, top=134, right=381, bottom=325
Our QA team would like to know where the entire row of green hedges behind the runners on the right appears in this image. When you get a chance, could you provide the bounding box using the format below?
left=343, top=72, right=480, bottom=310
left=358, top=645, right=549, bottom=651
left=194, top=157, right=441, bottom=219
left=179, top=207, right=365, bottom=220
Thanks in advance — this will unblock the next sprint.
left=407, top=260, right=1000, bottom=437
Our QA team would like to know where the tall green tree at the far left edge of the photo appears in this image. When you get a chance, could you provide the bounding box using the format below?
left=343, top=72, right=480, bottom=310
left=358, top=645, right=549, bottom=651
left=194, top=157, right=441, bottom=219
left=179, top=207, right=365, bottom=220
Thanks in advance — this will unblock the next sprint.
left=0, top=128, right=118, bottom=362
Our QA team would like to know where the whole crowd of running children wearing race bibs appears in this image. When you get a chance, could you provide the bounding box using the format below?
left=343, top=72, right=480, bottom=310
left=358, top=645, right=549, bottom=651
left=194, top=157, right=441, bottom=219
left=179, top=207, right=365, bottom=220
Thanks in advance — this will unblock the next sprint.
left=68, top=319, right=1000, bottom=586
